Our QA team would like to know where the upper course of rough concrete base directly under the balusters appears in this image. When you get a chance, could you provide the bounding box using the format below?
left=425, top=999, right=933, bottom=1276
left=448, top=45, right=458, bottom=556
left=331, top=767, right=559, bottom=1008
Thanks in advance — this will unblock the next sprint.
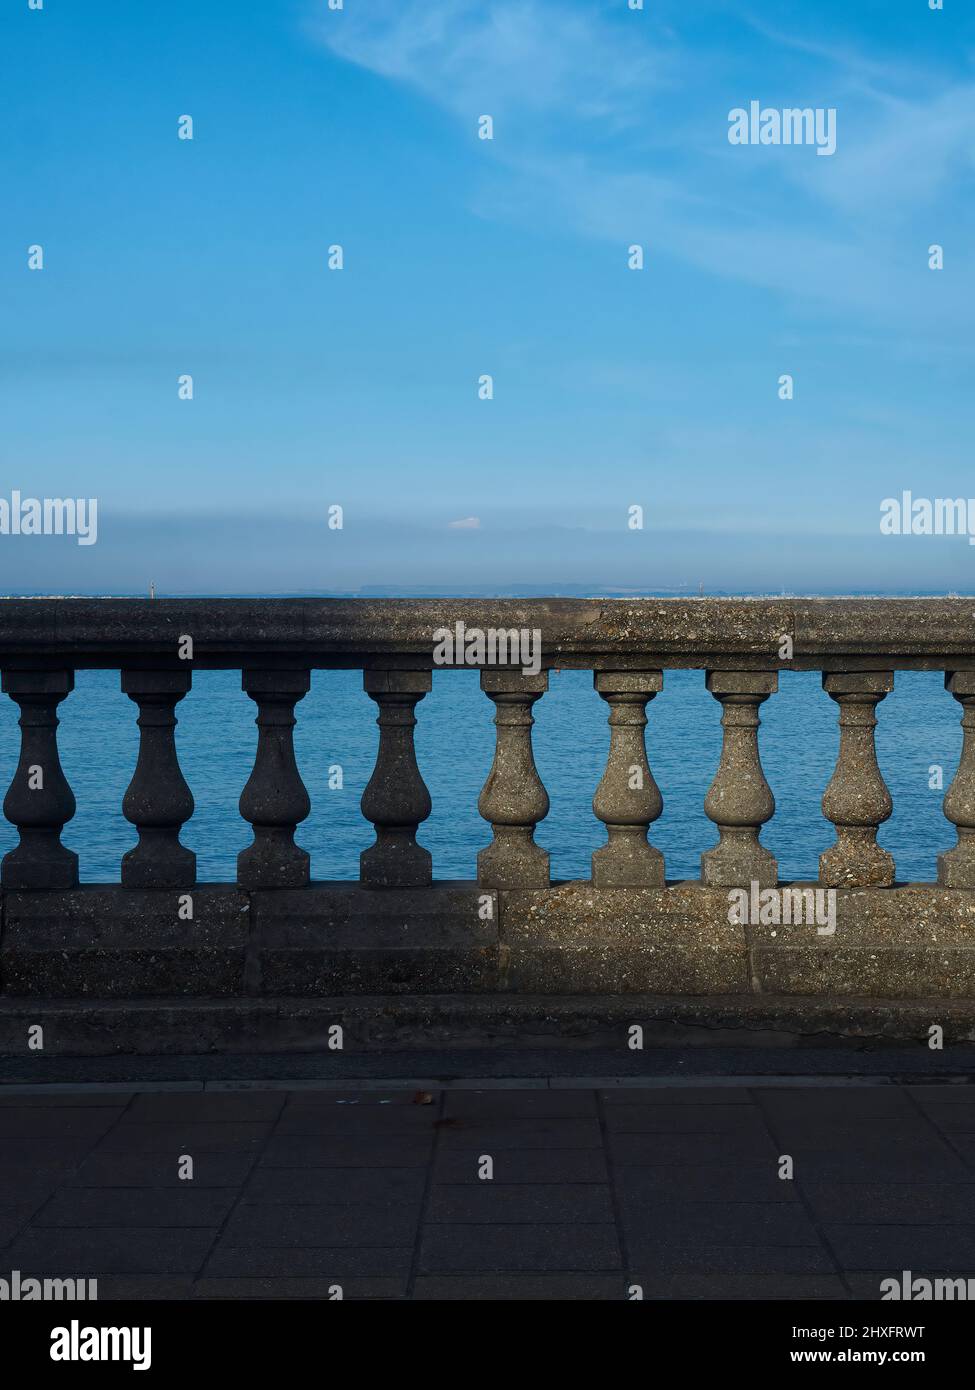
left=0, top=881, right=975, bottom=1019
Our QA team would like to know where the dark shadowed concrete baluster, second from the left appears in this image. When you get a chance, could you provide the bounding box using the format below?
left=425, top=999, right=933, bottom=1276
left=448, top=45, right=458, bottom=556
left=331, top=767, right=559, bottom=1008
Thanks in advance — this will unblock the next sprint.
left=122, top=671, right=196, bottom=888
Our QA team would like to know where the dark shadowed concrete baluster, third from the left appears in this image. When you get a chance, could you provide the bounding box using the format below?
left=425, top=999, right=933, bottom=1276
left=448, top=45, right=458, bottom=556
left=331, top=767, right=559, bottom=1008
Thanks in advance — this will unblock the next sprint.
left=236, top=670, right=312, bottom=888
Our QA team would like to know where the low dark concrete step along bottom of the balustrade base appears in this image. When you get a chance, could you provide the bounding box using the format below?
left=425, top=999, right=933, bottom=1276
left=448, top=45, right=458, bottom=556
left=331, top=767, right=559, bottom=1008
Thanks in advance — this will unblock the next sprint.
left=0, top=992, right=975, bottom=1056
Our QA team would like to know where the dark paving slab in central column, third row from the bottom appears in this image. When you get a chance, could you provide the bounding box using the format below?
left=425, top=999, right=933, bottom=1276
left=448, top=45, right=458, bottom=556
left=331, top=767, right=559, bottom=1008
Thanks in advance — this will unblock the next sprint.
left=427, top=1183, right=613, bottom=1225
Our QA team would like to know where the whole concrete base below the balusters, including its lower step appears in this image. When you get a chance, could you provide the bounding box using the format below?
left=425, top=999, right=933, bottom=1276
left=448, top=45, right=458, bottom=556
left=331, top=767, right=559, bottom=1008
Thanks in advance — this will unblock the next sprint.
left=0, top=883, right=975, bottom=1055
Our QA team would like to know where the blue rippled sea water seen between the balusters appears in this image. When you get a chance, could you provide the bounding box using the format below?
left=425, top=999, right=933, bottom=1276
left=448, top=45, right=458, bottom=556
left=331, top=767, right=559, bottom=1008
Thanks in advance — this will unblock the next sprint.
left=0, top=671, right=961, bottom=883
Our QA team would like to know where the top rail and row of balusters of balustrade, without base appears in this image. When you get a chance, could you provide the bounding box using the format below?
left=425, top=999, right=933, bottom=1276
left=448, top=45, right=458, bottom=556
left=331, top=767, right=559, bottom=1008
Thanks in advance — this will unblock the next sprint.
left=0, top=598, right=975, bottom=891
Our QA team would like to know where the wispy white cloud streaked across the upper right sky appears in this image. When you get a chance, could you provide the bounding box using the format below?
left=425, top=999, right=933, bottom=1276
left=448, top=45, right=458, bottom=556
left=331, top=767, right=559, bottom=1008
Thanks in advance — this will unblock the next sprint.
left=316, top=0, right=975, bottom=327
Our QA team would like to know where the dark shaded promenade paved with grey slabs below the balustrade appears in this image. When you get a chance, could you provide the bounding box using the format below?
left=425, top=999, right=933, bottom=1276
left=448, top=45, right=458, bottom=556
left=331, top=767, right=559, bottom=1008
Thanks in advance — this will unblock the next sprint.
left=0, top=1081, right=975, bottom=1300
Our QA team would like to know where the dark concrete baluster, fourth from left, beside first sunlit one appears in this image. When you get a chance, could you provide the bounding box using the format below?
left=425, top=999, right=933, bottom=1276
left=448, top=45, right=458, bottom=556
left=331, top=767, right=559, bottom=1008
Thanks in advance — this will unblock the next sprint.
left=359, top=671, right=433, bottom=888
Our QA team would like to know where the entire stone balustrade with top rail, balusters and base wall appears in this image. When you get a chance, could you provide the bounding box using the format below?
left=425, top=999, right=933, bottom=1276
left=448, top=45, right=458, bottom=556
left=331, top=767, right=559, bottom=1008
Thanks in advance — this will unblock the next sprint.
left=0, top=599, right=975, bottom=1050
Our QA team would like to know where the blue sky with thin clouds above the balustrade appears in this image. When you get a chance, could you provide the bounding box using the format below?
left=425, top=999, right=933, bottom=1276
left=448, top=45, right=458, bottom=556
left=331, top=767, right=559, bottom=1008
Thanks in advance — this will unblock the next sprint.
left=0, top=0, right=975, bottom=594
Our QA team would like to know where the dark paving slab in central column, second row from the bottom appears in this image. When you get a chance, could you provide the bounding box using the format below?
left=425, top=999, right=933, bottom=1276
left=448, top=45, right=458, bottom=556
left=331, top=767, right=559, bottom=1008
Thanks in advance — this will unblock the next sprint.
left=420, top=1223, right=622, bottom=1275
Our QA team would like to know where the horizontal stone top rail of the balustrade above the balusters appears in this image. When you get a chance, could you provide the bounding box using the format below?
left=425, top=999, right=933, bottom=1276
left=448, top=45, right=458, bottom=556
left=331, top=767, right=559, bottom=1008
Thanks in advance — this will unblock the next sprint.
left=0, top=598, right=975, bottom=670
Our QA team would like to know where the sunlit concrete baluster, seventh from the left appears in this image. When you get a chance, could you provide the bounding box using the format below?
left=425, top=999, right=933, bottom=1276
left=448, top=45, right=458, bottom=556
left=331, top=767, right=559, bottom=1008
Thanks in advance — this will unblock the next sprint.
left=701, top=671, right=779, bottom=888
